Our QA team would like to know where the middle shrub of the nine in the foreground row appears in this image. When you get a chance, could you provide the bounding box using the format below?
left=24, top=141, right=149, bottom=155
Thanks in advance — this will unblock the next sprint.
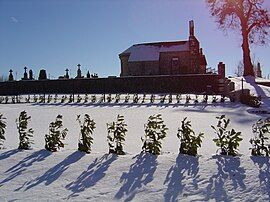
left=107, top=114, right=128, bottom=155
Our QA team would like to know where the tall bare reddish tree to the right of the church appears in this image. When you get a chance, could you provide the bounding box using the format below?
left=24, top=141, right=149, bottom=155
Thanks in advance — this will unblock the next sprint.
left=206, top=0, right=270, bottom=76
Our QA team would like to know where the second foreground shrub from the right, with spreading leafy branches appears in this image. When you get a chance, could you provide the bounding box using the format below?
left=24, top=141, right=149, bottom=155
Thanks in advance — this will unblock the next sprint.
left=211, top=115, right=243, bottom=156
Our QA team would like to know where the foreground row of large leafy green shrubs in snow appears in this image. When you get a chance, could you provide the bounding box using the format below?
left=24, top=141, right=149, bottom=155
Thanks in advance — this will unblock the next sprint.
left=0, top=111, right=270, bottom=156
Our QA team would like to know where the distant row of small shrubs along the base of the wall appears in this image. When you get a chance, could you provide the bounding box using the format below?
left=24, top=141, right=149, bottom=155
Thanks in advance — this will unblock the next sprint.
left=0, top=93, right=225, bottom=104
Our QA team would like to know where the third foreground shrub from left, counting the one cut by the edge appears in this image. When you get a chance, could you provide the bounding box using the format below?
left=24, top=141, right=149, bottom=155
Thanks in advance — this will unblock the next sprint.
left=45, top=115, right=68, bottom=152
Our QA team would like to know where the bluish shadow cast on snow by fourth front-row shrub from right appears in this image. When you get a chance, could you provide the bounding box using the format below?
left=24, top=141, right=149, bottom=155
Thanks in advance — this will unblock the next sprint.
left=115, top=153, right=157, bottom=201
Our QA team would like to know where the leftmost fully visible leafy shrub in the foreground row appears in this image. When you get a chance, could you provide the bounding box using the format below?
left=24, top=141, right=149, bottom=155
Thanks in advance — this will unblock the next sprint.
left=16, top=111, right=34, bottom=149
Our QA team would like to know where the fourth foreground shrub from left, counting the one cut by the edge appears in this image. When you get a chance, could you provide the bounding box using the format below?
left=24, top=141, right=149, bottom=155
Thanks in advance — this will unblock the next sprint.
left=77, top=114, right=96, bottom=154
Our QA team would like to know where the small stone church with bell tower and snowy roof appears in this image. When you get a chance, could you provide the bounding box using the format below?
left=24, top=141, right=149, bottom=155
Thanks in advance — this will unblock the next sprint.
left=119, top=21, right=207, bottom=77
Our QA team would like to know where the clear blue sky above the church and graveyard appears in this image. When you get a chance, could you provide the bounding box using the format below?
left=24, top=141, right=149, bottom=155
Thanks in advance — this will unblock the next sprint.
left=0, top=0, right=270, bottom=78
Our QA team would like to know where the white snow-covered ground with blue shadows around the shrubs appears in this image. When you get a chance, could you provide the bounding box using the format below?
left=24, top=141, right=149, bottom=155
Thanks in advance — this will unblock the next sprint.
left=0, top=78, right=270, bottom=201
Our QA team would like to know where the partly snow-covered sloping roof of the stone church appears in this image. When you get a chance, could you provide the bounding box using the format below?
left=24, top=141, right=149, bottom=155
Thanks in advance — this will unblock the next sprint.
left=122, top=41, right=189, bottom=62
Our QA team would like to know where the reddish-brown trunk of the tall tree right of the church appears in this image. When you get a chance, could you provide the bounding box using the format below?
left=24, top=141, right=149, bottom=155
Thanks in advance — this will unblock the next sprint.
left=242, top=28, right=254, bottom=76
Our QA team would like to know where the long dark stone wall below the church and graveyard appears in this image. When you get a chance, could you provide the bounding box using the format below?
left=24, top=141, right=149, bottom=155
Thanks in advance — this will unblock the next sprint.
left=0, top=74, right=223, bottom=95
